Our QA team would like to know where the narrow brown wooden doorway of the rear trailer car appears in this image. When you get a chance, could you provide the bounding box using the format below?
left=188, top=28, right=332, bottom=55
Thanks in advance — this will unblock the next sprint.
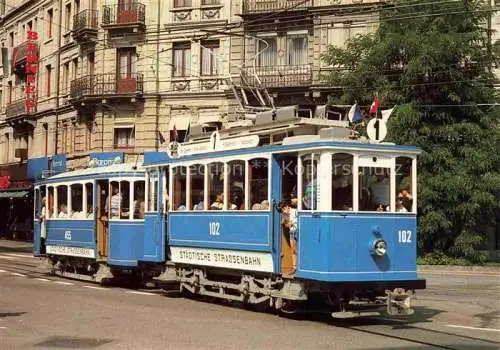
left=96, top=180, right=110, bottom=260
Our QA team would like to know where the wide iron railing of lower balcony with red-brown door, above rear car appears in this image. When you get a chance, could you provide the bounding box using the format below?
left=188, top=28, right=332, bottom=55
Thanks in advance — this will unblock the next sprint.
left=70, top=73, right=144, bottom=99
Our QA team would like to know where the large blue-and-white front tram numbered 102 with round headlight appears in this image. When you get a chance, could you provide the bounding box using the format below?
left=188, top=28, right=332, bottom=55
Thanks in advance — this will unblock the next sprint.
left=144, top=136, right=426, bottom=317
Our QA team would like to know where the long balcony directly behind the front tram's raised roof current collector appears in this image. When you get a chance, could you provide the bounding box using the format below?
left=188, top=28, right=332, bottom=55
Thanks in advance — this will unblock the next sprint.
left=242, top=65, right=313, bottom=88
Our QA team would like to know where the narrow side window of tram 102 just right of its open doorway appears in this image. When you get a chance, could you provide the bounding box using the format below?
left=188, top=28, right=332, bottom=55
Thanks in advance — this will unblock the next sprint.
left=302, top=153, right=319, bottom=210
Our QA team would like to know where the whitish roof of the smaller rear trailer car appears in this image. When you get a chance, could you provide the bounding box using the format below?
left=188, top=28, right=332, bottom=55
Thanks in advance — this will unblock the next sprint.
left=34, top=163, right=145, bottom=183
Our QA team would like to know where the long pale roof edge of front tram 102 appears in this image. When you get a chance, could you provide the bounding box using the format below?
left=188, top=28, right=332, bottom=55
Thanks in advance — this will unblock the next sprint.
left=143, top=136, right=422, bottom=167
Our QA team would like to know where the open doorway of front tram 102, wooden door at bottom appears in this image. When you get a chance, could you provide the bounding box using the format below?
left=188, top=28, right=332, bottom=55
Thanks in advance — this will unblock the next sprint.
left=273, top=154, right=297, bottom=274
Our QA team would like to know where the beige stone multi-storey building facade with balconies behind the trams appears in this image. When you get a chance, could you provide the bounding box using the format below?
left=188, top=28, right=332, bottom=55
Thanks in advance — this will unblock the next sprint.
left=0, top=0, right=500, bottom=254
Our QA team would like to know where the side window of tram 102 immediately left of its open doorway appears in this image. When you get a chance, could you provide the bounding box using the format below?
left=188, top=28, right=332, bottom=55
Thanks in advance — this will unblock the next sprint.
left=248, top=158, right=269, bottom=210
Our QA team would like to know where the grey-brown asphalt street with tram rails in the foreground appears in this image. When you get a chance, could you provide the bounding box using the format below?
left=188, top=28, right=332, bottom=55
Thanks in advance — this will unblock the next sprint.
left=0, top=241, right=500, bottom=350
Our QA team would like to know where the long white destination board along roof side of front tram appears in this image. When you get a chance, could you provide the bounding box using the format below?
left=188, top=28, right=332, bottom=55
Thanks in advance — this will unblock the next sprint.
left=167, top=132, right=259, bottom=158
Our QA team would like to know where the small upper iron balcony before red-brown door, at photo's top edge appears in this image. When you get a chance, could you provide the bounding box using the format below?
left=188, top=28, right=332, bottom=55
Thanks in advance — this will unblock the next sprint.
left=101, top=2, right=146, bottom=35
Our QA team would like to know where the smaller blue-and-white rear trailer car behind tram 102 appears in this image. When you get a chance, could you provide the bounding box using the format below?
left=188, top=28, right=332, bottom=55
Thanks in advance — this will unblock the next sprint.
left=34, top=164, right=156, bottom=283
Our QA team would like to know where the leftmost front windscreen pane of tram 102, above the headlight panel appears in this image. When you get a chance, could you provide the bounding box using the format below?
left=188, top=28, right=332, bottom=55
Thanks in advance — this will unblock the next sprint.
left=332, top=153, right=354, bottom=210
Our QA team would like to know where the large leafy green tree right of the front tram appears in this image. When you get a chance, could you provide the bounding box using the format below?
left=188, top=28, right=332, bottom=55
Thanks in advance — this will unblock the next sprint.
left=323, top=0, right=500, bottom=262
